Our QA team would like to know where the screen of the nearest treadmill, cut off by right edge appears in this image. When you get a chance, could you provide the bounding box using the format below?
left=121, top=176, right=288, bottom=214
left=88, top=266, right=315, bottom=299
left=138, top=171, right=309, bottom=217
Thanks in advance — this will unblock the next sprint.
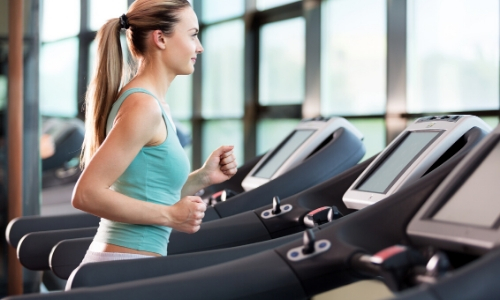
left=433, top=143, right=500, bottom=228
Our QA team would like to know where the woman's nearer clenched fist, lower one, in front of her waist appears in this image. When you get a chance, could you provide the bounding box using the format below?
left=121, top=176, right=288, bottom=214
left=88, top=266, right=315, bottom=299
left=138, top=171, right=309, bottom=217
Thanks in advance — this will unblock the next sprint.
left=166, top=196, right=207, bottom=233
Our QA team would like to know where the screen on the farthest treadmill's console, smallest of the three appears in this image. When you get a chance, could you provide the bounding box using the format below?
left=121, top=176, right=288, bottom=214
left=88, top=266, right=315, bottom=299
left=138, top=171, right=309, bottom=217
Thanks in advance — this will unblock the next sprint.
left=253, top=130, right=315, bottom=179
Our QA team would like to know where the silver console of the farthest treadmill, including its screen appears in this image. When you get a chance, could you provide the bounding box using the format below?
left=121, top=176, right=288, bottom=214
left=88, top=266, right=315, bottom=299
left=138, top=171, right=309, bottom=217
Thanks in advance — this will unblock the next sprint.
left=241, top=117, right=363, bottom=191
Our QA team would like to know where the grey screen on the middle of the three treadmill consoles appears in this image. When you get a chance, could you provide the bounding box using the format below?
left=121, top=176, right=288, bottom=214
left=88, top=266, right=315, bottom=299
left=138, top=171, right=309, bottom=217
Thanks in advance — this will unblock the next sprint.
left=357, top=131, right=441, bottom=193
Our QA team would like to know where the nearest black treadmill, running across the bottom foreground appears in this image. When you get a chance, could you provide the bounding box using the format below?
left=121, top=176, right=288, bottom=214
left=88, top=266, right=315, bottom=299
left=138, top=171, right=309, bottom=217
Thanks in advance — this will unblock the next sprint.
left=1, top=120, right=494, bottom=299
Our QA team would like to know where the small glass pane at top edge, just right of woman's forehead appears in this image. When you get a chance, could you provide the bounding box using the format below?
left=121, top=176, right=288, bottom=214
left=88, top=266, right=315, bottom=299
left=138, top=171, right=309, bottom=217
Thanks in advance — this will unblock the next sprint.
left=202, top=0, right=245, bottom=23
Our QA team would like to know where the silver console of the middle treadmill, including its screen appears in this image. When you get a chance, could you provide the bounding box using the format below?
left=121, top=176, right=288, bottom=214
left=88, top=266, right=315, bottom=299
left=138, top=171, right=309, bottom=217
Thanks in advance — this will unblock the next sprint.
left=343, top=115, right=491, bottom=209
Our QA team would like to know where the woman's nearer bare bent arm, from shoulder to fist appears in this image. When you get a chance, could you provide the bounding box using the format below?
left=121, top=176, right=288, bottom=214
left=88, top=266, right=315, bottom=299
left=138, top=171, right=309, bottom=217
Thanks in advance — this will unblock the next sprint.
left=72, top=93, right=206, bottom=233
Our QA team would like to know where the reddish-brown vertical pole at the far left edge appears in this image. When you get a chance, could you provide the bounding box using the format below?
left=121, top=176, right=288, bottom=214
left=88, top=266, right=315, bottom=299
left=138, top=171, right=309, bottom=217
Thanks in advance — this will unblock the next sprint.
left=7, top=0, right=24, bottom=295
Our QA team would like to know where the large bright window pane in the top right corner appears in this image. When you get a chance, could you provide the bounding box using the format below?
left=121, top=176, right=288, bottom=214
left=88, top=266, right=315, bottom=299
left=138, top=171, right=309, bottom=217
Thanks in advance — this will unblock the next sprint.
left=407, top=0, right=500, bottom=113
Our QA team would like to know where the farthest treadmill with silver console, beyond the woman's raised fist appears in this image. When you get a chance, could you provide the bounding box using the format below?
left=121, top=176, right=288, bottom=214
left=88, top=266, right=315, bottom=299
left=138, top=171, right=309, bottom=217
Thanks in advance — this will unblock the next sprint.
left=6, top=118, right=365, bottom=270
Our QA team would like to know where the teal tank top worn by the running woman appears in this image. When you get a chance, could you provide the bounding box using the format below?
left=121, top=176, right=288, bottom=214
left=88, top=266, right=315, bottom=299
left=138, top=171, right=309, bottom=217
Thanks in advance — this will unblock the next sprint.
left=94, top=88, right=190, bottom=256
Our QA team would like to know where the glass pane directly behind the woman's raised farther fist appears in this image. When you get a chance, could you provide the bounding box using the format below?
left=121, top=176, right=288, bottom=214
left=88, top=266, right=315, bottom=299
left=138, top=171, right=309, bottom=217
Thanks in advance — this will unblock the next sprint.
left=202, top=120, right=244, bottom=165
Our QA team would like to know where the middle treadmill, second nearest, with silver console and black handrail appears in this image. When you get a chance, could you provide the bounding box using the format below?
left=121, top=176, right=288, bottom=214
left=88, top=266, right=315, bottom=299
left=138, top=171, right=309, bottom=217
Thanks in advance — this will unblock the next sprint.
left=50, top=113, right=489, bottom=286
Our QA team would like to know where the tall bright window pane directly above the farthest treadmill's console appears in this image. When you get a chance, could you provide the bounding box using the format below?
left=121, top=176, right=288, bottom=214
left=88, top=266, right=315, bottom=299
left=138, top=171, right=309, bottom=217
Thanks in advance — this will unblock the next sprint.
left=321, top=0, right=387, bottom=116
